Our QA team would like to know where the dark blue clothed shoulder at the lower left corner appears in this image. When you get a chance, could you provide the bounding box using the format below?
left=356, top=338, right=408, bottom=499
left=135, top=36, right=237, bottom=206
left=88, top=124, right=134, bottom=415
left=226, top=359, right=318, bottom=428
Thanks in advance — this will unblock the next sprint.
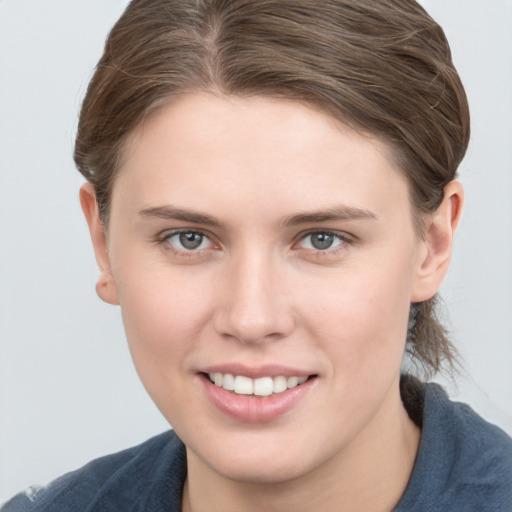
left=1, top=431, right=186, bottom=512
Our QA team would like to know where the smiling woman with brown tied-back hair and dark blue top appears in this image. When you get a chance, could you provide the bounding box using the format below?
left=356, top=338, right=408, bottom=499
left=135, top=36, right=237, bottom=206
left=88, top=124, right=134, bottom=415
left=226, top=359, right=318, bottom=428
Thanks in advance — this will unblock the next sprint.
left=4, top=0, right=512, bottom=511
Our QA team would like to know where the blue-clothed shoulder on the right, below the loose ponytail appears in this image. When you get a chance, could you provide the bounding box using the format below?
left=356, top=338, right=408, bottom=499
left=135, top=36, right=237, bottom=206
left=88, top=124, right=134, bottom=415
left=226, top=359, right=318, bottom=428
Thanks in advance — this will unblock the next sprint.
left=396, top=384, right=512, bottom=512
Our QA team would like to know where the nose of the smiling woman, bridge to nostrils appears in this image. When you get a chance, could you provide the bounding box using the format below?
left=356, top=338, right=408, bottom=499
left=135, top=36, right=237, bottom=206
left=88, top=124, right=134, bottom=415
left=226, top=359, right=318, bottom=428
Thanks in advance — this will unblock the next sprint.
left=215, top=251, right=295, bottom=344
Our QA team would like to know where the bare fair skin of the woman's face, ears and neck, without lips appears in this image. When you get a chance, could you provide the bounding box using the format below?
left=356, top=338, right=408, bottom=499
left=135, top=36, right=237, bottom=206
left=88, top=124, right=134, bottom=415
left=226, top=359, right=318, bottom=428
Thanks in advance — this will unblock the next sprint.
left=81, top=93, right=462, bottom=512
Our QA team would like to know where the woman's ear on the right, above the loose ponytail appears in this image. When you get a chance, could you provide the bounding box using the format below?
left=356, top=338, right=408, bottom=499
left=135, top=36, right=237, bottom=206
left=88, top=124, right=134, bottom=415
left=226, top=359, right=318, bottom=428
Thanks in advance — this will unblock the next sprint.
left=411, top=180, right=464, bottom=302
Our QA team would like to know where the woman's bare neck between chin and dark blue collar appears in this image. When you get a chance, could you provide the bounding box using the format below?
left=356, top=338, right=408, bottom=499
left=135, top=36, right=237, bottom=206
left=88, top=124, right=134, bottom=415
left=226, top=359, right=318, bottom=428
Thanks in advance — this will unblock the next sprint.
left=183, top=380, right=420, bottom=512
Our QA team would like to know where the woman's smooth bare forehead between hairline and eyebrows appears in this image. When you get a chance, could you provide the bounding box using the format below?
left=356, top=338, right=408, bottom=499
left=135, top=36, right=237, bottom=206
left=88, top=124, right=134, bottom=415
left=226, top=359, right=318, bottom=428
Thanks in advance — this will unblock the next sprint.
left=113, top=93, right=408, bottom=224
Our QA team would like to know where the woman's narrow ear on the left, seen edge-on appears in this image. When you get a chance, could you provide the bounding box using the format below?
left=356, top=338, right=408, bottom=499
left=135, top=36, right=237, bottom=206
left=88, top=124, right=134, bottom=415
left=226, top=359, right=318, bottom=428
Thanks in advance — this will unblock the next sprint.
left=80, top=183, right=119, bottom=305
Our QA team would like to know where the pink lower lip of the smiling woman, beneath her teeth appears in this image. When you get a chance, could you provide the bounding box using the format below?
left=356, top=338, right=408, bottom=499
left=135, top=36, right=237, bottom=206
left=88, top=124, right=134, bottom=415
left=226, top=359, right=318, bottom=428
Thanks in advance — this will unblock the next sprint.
left=200, top=374, right=316, bottom=423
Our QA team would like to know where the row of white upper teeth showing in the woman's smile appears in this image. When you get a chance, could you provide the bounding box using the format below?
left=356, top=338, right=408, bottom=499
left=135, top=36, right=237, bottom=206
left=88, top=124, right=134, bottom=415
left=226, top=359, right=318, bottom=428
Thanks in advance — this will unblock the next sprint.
left=208, top=373, right=308, bottom=396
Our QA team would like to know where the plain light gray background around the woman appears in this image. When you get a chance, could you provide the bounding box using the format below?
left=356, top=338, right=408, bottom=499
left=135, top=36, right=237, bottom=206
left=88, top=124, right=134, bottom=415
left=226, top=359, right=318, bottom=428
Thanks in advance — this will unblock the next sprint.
left=0, top=0, right=512, bottom=502
